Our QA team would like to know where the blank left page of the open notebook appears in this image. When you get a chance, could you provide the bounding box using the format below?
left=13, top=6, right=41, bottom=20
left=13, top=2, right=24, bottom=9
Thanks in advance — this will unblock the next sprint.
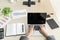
left=6, top=23, right=16, bottom=36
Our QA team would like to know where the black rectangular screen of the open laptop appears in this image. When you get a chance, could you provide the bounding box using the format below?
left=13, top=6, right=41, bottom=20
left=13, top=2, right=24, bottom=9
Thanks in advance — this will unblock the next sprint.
left=27, top=13, right=46, bottom=24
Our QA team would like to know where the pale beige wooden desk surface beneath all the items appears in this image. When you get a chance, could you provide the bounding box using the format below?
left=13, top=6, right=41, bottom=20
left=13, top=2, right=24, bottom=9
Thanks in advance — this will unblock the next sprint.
left=0, top=0, right=60, bottom=40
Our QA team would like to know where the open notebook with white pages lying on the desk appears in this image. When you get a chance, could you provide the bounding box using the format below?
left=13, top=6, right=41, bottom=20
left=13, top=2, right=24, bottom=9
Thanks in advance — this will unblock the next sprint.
left=6, top=23, right=25, bottom=36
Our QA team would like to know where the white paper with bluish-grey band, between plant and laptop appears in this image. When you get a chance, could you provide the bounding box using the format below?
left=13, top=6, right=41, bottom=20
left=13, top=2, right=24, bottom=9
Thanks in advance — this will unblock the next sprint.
left=12, top=9, right=27, bottom=19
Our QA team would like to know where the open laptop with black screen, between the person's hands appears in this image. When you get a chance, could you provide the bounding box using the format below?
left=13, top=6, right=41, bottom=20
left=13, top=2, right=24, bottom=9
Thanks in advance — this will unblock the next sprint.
left=27, top=13, right=47, bottom=35
